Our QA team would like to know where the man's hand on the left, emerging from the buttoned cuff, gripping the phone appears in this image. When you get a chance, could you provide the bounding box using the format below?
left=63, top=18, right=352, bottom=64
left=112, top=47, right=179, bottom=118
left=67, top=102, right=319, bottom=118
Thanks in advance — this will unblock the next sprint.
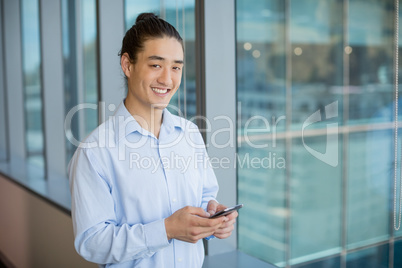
left=165, top=206, right=228, bottom=243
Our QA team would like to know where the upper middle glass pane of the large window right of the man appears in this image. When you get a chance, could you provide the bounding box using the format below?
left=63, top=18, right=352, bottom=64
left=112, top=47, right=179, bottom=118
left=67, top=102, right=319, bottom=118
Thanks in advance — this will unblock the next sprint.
left=288, top=0, right=343, bottom=130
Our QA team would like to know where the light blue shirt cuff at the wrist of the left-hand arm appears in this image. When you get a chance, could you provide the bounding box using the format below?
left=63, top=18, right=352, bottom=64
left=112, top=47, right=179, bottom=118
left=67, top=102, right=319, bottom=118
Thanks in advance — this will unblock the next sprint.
left=144, top=219, right=169, bottom=252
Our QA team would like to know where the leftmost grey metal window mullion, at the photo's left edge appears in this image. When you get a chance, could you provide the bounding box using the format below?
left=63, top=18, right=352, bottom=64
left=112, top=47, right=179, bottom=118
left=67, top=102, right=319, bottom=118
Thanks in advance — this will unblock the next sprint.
left=3, top=1, right=27, bottom=159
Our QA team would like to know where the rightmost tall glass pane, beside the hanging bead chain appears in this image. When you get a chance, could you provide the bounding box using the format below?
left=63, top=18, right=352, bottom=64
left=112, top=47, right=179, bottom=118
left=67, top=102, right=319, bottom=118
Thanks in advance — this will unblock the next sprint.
left=345, top=0, right=394, bottom=248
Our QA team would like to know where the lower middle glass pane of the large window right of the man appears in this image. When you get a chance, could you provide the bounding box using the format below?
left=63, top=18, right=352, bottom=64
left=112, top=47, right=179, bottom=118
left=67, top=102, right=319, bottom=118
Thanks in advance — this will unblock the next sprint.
left=290, top=136, right=342, bottom=263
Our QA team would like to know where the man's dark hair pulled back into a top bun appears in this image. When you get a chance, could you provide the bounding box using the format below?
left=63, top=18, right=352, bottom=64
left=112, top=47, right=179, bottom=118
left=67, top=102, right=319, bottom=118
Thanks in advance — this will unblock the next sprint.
left=119, top=13, right=184, bottom=63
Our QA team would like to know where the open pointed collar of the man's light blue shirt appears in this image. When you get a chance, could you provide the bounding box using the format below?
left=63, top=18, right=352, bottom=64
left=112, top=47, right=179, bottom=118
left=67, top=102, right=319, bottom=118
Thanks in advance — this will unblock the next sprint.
left=114, top=99, right=185, bottom=142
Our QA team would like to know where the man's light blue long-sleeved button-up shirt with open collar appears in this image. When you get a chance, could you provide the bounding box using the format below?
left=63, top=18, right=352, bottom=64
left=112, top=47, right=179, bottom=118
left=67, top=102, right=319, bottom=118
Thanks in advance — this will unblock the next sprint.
left=68, top=102, right=218, bottom=268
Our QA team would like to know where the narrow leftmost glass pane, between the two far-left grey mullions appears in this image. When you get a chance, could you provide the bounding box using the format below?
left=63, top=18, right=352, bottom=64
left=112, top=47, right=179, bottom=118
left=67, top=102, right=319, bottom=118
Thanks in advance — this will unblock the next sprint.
left=21, top=0, right=45, bottom=167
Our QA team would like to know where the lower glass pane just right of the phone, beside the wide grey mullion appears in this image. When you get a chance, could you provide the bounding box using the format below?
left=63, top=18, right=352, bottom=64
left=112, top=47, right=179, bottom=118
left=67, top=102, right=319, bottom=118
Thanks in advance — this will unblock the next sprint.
left=237, top=140, right=287, bottom=263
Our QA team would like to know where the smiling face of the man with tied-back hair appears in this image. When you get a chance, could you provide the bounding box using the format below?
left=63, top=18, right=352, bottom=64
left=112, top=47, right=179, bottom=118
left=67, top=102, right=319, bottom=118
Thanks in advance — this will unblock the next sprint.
left=127, top=37, right=184, bottom=112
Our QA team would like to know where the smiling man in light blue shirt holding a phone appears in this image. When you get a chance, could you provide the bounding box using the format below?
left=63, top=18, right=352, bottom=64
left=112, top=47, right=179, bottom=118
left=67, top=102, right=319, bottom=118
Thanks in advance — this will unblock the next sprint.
left=69, top=13, right=238, bottom=268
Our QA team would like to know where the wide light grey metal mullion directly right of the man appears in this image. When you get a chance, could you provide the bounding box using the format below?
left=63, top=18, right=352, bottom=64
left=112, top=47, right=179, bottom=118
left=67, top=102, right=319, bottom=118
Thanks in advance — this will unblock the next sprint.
left=201, top=0, right=237, bottom=255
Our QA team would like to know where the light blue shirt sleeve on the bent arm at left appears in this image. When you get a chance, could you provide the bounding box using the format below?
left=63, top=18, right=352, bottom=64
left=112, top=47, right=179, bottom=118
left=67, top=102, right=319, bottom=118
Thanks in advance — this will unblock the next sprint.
left=68, top=148, right=169, bottom=264
